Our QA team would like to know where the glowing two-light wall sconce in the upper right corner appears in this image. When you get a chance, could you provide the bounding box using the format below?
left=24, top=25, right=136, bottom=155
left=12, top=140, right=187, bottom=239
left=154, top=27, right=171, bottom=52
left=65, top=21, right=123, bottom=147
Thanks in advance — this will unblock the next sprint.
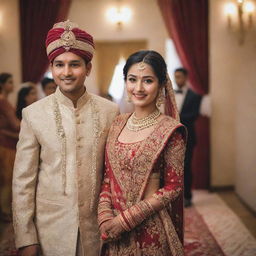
left=225, top=0, right=255, bottom=45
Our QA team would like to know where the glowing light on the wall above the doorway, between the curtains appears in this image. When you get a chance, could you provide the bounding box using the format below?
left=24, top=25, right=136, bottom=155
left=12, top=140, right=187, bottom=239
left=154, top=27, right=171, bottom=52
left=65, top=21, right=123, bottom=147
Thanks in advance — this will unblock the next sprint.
left=106, top=5, right=132, bottom=29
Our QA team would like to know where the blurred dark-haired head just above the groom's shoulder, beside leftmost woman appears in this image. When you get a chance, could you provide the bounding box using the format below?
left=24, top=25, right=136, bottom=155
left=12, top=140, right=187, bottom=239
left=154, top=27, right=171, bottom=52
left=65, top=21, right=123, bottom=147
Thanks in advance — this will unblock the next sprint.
left=16, top=85, right=38, bottom=120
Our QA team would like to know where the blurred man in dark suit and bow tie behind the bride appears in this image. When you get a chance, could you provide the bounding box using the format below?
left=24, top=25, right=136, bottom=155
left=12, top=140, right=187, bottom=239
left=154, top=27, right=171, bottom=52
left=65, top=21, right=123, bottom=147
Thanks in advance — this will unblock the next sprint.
left=174, top=68, right=201, bottom=207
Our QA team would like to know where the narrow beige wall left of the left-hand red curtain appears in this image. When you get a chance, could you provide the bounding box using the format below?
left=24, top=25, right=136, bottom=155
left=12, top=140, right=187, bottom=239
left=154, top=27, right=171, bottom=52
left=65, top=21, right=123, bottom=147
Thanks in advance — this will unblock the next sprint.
left=0, top=0, right=21, bottom=104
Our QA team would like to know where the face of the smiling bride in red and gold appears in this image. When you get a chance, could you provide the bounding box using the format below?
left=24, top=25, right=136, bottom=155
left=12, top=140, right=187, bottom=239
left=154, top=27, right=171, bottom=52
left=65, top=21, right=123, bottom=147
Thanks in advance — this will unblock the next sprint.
left=126, top=62, right=160, bottom=108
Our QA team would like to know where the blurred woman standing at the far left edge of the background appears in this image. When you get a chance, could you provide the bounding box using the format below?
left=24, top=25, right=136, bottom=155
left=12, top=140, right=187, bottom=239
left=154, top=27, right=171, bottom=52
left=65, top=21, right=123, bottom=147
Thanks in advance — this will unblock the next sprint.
left=0, top=73, right=20, bottom=221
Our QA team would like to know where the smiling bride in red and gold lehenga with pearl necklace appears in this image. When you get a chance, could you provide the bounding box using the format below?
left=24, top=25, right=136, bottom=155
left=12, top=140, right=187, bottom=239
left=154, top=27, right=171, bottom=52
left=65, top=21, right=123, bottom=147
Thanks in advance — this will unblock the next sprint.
left=98, top=51, right=186, bottom=256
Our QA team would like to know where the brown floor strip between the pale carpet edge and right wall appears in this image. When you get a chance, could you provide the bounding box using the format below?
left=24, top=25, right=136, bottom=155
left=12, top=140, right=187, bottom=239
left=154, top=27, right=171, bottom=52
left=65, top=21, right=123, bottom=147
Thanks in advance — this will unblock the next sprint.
left=217, top=191, right=256, bottom=238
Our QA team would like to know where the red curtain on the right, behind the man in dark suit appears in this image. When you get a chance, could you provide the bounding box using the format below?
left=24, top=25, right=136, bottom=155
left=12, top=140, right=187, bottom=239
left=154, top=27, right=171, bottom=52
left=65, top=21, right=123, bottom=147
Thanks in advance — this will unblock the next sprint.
left=158, top=0, right=210, bottom=188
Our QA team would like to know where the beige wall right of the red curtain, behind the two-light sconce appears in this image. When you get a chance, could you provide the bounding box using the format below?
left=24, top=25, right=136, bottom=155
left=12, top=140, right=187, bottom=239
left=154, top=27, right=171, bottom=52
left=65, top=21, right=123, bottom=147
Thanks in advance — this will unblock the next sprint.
left=210, top=0, right=256, bottom=210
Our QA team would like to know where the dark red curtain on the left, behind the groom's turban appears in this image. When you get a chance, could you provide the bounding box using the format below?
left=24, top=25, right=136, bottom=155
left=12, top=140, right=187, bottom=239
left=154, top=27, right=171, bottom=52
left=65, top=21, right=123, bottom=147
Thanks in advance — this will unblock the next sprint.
left=19, top=0, right=71, bottom=83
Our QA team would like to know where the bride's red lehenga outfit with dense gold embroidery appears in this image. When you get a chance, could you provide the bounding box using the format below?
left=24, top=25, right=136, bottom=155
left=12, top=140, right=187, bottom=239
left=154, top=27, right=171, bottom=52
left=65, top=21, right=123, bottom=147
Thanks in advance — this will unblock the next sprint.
left=98, top=114, right=186, bottom=256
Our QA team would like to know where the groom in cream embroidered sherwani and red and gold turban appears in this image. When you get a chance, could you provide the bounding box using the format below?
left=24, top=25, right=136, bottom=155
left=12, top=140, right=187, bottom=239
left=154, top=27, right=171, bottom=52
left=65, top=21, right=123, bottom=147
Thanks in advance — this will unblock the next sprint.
left=13, top=21, right=119, bottom=256
